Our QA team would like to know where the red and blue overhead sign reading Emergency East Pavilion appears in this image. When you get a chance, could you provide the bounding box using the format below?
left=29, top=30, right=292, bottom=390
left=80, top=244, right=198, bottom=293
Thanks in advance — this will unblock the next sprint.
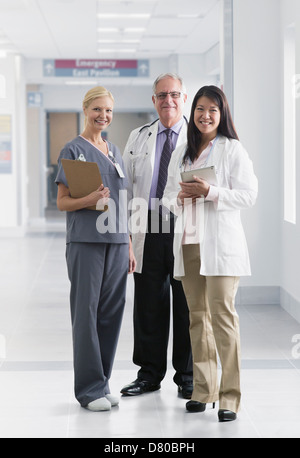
left=43, top=59, right=149, bottom=78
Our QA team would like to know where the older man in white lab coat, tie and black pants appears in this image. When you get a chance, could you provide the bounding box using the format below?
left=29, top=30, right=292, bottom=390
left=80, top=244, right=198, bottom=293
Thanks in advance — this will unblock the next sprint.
left=121, top=73, right=193, bottom=399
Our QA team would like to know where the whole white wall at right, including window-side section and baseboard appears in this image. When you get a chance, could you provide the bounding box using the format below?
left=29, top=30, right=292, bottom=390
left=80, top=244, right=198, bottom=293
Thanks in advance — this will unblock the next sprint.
left=233, top=0, right=300, bottom=322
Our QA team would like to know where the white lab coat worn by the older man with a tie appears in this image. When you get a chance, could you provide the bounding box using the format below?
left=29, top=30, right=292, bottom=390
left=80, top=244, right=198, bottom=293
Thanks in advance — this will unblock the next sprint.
left=123, top=119, right=187, bottom=273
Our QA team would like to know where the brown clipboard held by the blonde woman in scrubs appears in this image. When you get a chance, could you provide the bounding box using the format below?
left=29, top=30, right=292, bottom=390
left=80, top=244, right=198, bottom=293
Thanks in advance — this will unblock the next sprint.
left=61, top=159, right=108, bottom=211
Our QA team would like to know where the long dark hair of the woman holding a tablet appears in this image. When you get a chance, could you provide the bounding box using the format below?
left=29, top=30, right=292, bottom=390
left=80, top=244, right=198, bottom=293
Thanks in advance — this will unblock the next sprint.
left=183, top=86, right=239, bottom=164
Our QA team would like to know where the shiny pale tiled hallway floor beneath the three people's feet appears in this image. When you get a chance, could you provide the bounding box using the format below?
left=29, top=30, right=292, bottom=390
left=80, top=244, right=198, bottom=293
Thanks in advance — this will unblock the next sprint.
left=0, top=227, right=300, bottom=440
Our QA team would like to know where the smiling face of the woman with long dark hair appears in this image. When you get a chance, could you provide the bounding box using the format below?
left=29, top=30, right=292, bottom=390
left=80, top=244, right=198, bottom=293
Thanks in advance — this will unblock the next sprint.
left=194, top=96, right=221, bottom=140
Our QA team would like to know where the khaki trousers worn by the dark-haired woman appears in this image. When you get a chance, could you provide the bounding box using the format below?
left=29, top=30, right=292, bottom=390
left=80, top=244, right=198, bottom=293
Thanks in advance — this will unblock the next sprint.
left=181, top=245, right=241, bottom=412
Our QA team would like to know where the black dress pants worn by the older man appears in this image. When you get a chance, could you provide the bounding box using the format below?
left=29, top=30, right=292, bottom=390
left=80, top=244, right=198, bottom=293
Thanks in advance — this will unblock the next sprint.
left=133, top=212, right=193, bottom=385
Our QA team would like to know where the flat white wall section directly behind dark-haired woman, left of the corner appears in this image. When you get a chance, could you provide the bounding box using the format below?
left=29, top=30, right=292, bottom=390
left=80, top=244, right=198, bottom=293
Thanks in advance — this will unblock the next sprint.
left=233, top=0, right=282, bottom=294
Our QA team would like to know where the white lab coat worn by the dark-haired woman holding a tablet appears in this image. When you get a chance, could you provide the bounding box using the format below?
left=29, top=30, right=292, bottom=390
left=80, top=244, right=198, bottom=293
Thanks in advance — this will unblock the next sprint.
left=163, top=136, right=258, bottom=279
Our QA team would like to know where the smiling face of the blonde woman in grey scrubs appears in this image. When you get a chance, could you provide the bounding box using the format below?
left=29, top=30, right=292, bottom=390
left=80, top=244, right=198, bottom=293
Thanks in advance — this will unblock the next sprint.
left=83, top=96, right=114, bottom=132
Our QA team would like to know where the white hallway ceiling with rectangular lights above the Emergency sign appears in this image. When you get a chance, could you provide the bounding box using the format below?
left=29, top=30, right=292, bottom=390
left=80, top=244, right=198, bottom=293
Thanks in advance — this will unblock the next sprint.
left=0, top=0, right=220, bottom=59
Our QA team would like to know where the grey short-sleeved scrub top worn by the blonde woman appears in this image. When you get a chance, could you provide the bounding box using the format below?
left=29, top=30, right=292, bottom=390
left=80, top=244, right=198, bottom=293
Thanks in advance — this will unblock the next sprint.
left=55, top=136, right=129, bottom=243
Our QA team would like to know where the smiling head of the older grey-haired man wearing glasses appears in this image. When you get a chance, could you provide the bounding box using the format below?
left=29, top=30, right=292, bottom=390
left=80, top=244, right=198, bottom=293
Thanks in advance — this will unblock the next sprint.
left=152, top=77, right=186, bottom=127
